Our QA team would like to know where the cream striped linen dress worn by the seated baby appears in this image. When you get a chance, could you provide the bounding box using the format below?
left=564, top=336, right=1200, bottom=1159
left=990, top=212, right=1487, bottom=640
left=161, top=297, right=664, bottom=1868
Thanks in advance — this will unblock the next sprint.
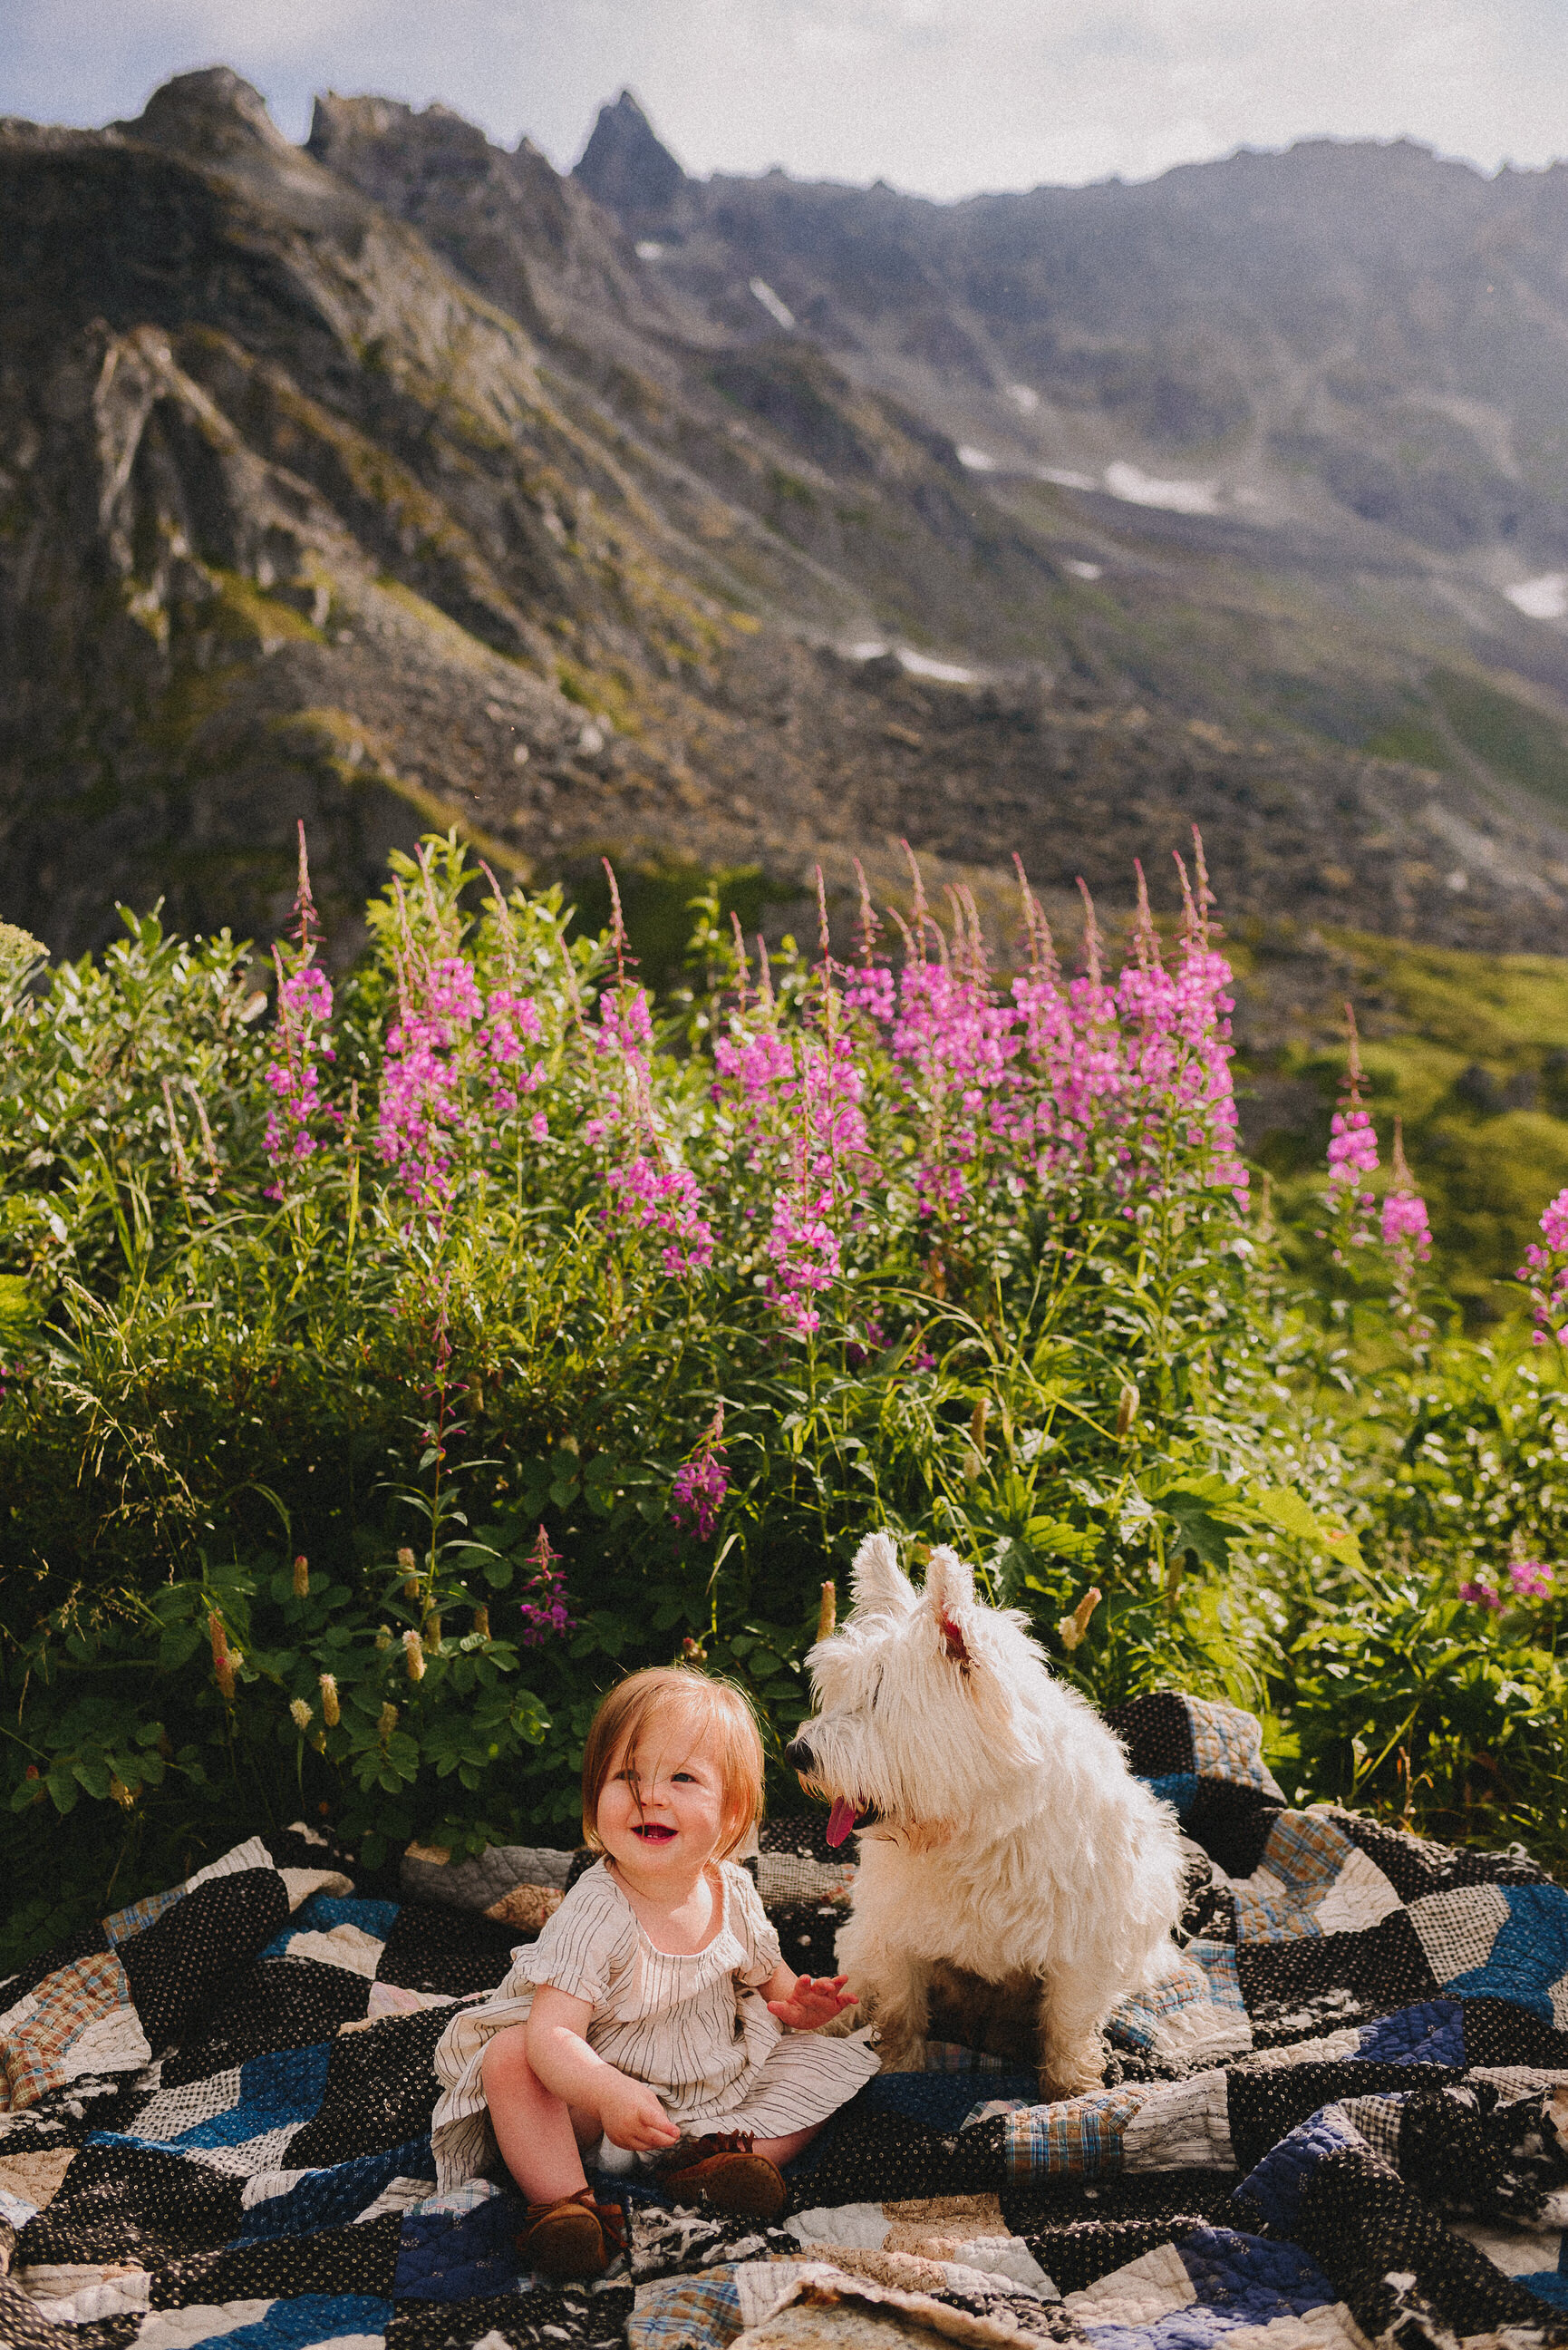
left=431, top=1861, right=879, bottom=2192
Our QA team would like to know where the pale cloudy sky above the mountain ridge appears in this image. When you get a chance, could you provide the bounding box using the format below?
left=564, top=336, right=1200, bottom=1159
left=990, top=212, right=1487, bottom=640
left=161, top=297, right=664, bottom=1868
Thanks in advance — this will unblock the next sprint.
left=0, top=0, right=1568, bottom=195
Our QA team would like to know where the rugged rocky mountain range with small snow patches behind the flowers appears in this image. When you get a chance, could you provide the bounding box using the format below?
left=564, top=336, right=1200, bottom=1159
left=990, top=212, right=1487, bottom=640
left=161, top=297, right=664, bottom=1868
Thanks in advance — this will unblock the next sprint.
left=0, top=71, right=1568, bottom=973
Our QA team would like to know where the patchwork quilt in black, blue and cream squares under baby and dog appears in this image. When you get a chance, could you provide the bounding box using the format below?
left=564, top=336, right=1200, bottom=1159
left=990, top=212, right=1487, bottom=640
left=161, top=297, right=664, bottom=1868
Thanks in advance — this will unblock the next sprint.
left=0, top=1695, right=1568, bottom=2350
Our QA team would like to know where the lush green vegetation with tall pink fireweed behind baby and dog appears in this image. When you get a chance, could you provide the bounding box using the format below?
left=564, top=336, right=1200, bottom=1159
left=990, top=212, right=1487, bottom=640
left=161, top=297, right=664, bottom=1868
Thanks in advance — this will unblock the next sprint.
left=0, top=839, right=1568, bottom=1967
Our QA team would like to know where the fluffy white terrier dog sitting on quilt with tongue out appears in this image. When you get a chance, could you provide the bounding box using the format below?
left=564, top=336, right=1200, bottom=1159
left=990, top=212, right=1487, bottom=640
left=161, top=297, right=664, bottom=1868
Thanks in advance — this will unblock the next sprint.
left=785, top=1535, right=1183, bottom=2096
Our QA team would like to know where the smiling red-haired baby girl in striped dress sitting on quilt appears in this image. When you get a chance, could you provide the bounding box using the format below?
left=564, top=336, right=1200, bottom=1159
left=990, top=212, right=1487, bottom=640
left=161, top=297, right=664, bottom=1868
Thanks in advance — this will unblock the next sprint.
left=432, top=1666, right=879, bottom=2277
